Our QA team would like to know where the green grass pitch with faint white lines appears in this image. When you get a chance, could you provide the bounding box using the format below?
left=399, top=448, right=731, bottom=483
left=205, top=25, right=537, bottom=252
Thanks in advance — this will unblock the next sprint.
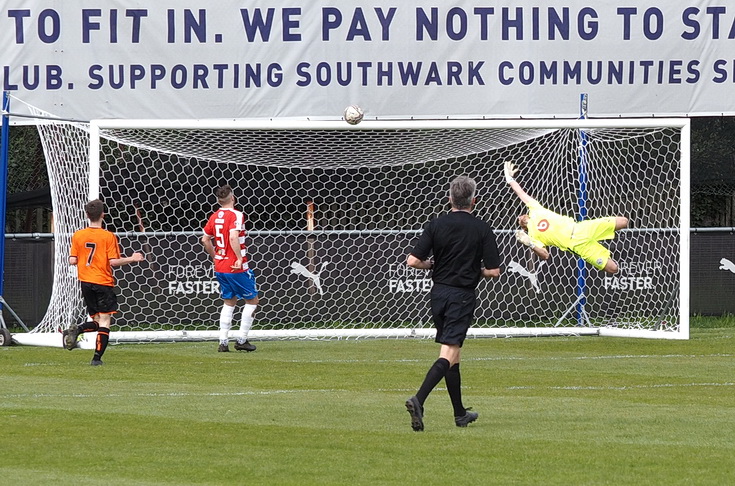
left=0, top=319, right=735, bottom=485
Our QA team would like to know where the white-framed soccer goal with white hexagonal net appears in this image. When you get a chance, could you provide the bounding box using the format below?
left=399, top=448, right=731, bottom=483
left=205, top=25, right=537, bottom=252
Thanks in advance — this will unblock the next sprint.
left=14, top=109, right=689, bottom=342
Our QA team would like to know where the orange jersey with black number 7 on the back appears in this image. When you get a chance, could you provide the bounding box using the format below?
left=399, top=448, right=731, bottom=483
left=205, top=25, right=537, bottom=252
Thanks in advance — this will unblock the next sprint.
left=69, top=227, right=120, bottom=286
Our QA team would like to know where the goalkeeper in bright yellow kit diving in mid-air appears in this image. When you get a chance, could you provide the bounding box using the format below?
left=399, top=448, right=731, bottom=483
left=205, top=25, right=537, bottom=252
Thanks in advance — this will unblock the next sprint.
left=504, top=162, right=628, bottom=273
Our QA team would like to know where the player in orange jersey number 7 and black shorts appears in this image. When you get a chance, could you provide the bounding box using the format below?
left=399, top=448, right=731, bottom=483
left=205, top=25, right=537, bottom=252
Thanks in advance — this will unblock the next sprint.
left=63, top=199, right=145, bottom=366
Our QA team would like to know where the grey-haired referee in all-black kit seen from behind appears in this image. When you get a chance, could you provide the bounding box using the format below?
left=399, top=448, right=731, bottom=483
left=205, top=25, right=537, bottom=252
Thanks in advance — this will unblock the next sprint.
left=406, top=176, right=500, bottom=431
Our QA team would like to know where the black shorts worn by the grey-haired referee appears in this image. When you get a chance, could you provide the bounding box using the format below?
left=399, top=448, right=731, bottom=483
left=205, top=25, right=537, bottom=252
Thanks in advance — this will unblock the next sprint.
left=431, top=284, right=477, bottom=347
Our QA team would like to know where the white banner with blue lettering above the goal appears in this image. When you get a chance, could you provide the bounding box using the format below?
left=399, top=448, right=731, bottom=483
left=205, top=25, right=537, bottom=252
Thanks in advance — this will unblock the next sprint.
left=0, top=0, right=735, bottom=120
